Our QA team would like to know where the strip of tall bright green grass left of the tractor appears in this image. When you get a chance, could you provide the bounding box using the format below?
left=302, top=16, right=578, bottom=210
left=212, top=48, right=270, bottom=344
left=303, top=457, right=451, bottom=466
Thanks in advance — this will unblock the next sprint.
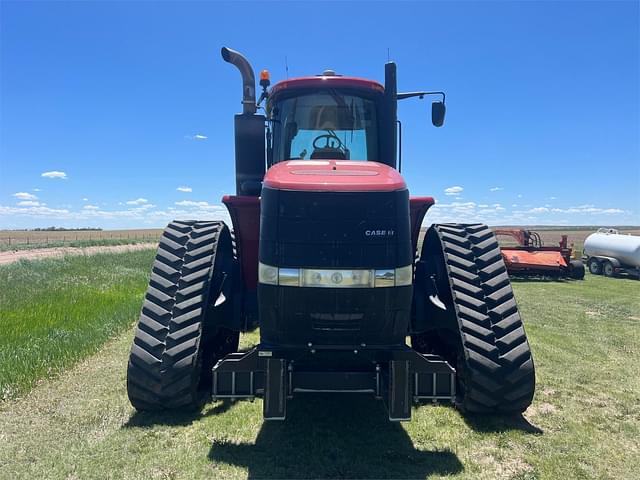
left=0, top=249, right=154, bottom=399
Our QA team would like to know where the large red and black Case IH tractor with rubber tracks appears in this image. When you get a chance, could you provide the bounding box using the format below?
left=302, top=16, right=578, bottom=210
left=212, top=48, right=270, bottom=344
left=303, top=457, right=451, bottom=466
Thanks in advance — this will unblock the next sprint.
left=127, top=48, right=535, bottom=421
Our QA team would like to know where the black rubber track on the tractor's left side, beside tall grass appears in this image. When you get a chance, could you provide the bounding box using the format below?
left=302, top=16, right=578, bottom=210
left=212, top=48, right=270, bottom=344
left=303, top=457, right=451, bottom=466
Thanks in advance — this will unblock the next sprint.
left=127, top=221, right=238, bottom=410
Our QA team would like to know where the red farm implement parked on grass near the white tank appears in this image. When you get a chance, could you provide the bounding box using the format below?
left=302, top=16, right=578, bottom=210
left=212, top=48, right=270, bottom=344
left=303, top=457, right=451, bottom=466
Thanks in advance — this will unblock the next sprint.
left=494, top=228, right=584, bottom=280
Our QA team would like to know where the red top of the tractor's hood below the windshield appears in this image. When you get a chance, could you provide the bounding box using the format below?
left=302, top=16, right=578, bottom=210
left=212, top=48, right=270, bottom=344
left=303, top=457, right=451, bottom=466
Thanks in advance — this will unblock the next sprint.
left=264, top=160, right=407, bottom=192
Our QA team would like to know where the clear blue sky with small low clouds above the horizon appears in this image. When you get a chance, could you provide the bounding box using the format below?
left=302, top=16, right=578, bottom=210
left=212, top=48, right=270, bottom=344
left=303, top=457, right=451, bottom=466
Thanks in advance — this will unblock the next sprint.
left=0, top=1, right=640, bottom=228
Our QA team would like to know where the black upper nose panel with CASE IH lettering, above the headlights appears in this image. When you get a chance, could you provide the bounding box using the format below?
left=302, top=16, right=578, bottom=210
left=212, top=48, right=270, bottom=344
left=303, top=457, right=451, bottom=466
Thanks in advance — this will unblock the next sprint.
left=260, top=188, right=413, bottom=268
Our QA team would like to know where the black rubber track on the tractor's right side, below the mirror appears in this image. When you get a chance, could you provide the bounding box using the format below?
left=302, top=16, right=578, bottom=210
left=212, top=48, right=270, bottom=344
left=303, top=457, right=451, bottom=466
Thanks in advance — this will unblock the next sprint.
left=418, top=224, right=535, bottom=413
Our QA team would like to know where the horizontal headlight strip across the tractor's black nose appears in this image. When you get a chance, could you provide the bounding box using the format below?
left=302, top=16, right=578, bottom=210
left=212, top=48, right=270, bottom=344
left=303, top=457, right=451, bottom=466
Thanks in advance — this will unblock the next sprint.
left=258, top=263, right=413, bottom=288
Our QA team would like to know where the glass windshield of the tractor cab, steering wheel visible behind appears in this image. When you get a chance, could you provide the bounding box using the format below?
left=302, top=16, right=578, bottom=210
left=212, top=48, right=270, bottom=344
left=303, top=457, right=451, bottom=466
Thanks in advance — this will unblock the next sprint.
left=271, top=89, right=378, bottom=162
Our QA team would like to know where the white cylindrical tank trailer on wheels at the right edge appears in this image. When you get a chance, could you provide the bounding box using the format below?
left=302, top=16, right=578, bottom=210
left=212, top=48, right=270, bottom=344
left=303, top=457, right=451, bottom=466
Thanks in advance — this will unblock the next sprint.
left=583, top=228, right=640, bottom=280
